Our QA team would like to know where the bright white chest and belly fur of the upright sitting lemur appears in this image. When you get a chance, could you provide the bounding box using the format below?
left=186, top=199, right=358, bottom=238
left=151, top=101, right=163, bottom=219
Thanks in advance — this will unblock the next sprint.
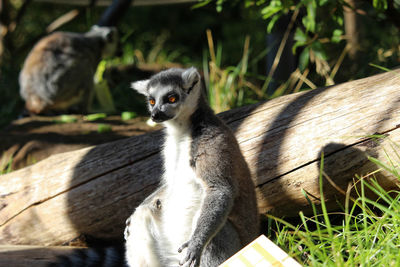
left=162, top=127, right=204, bottom=262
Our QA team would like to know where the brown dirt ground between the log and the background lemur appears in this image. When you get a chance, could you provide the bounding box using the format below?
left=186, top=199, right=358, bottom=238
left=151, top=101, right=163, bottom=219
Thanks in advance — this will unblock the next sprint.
left=0, top=115, right=160, bottom=172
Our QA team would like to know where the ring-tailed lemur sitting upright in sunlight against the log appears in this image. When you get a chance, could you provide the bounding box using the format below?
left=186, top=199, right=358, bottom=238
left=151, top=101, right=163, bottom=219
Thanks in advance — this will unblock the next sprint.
left=126, top=68, right=259, bottom=267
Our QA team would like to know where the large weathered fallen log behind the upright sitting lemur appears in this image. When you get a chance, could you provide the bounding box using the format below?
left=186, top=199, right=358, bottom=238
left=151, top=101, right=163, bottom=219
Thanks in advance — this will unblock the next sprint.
left=0, top=70, right=400, bottom=245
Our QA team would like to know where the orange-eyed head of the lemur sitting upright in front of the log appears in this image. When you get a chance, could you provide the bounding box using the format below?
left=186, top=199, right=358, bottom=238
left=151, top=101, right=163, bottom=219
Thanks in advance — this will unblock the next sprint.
left=132, top=68, right=200, bottom=123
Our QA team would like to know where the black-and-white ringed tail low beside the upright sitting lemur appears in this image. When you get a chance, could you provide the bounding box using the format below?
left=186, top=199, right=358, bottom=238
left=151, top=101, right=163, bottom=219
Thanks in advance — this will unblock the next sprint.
left=48, top=246, right=128, bottom=267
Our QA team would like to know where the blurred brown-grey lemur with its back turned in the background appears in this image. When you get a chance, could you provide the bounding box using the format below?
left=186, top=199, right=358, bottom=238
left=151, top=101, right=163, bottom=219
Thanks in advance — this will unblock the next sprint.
left=19, top=26, right=119, bottom=114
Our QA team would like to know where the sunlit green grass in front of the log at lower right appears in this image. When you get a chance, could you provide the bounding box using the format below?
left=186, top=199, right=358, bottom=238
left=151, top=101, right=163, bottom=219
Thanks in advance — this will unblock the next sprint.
left=269, top=151, right=400, bottom=266
